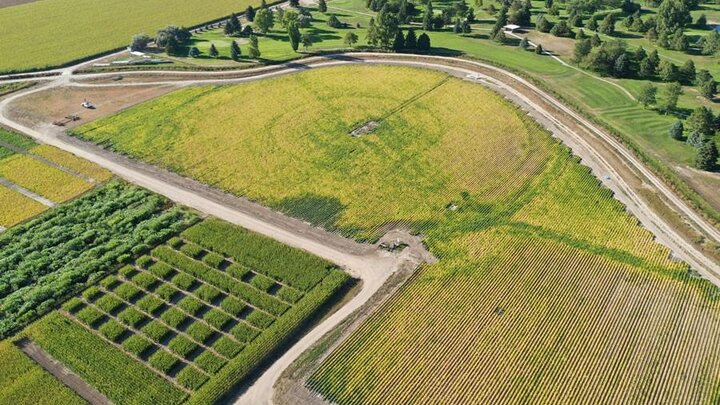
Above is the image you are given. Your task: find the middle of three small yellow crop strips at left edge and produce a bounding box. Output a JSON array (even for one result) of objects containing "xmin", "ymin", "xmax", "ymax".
[{"xmin": 0, "ymin": 155, "xmax": 92, "ymax": 203}]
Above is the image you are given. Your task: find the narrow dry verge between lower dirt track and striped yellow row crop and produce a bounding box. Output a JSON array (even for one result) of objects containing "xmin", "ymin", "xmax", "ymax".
[{"xmin": 273, "ymin": 256, "xmax": 422, "ymax": 405}]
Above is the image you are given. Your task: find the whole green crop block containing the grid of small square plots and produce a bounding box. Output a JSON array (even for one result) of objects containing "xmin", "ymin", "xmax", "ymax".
[{"xmin": 2, "ymin": 219, "xmax": 349, "ymax": 404}]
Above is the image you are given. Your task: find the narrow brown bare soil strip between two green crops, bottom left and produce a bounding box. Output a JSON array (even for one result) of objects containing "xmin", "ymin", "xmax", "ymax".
[{"xmin": 15, "ymin": 337, "xmax": 112, "ymax": 405}]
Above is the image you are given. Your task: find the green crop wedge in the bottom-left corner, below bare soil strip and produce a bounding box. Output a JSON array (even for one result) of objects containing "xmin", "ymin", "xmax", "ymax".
[{"xmin": 0, "ymin": 340, "xmax": 86, "ymax": 405}]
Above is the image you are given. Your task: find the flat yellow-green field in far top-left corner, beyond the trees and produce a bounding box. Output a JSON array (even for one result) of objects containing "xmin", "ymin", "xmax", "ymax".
[{"xmin": 0, "ymin": 0, "xmax": 259, "ymax": 73}]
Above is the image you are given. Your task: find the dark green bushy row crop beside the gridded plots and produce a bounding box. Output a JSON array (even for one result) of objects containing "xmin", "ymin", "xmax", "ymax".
[{"xmin": 0, "ymin": 182, "xmax": 195, "ymax": 337}]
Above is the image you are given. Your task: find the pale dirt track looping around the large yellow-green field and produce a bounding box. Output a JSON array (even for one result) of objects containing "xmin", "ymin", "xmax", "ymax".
[{"xmin": 0, "ymin": 53, "xmax": 720, "ymax": 404}]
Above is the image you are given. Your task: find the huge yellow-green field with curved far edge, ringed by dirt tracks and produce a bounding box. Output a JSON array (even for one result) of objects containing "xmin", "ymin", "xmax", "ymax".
[{"xmin": 78, "ymin": 64, "xmax": 720, "ymax": 404}]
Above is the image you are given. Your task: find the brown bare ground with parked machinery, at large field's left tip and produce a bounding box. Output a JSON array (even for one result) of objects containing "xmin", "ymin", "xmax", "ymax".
[{"xmin": 9, "ymin": 85, "xmax": 175, "ymax": 128}]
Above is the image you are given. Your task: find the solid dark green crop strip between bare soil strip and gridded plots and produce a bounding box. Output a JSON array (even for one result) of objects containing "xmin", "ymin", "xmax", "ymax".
[{"xmin": 23, "ymin": 312, "xmax": 186, "ymax": 404}]
